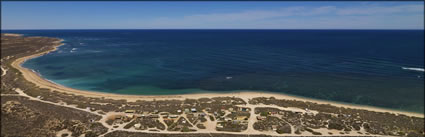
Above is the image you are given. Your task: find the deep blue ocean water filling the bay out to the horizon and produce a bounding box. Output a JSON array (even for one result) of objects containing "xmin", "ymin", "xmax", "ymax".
[{"xmin": 3, "ymin": 30, "xmax": 424, "ymax": 113}]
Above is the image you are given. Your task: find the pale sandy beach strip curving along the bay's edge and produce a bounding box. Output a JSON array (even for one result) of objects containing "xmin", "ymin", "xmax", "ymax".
[{"xmin": 11, "ymin": 35, "xmax": 424, "ymax": 118}]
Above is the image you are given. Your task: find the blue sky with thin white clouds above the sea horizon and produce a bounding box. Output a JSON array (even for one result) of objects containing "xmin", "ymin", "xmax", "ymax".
[{"xmin": 1, "ymin": 1, "xmax": 424, "ymax": 30}]
